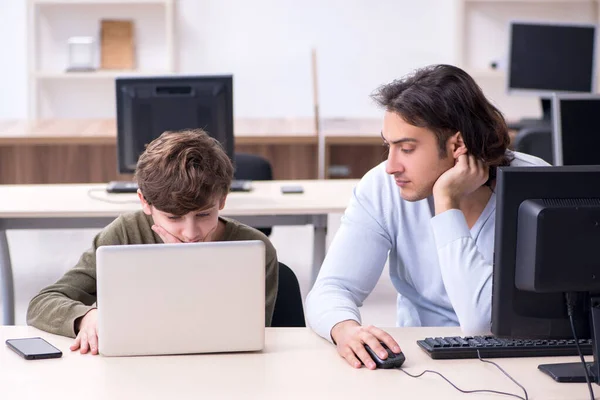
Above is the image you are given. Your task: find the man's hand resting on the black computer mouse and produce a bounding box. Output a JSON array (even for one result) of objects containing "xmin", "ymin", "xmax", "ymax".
[{"xmin": 331, "ymin": 320, "xmax": 400, "ymax": 369}]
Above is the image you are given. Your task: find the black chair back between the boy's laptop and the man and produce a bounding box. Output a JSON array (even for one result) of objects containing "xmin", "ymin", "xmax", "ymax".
[{"xmin": 271, "ymin": 262, "xmax": 306, "ymax": 328}]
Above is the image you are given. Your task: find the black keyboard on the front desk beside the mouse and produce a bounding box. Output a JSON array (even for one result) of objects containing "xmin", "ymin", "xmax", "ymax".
[{"xmin": 417, "ymin": 336, "xmax": 592, "ymax": 360}]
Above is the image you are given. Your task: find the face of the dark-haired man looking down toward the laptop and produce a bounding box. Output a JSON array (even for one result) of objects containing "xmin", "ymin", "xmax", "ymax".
[{"xmin": 381, "ymin": 111, "xmax": 454, "ymax": 201}]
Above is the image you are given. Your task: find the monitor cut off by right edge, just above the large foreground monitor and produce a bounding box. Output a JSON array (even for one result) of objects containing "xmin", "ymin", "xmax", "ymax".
[{"xmin": 552, "ymin": 94, "xmax": 600, "ymax": 165}]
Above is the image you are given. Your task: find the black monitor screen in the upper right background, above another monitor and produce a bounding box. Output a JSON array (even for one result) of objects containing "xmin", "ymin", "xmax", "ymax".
[{"xmin": 508, "ymin": 22, "xmax": 596, "ymax": 93}]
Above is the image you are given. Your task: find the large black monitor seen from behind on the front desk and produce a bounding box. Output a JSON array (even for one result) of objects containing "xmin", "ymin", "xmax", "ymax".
[{"xmin": 492, "ymin": 166, "xmax": 600, "ymax": 384}]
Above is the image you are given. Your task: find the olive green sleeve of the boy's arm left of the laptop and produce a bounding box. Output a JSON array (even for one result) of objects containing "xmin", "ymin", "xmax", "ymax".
[{"xmin": 27, "ymin": 218, "xmax": 124, "ymax": 337}]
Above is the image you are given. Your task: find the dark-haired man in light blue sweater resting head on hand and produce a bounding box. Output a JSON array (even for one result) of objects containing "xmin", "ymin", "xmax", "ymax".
[{"xmin": 306, "ymin": 65, "xmax": 546, "ymax": 369}]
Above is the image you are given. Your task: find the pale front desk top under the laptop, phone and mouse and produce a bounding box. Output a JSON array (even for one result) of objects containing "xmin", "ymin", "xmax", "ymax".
[{"xmin": 0, "ymin": 326, "xmax": 600, "ymax": 400}]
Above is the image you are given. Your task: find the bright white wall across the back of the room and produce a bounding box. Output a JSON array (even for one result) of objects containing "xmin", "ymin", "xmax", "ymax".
[{"xmin": 0, "ymin": 0, "xmax": 598, "ymax": 119}]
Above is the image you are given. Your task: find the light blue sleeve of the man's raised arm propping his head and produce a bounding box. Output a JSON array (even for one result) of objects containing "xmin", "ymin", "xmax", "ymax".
[{"xmin": 431, "ymin": 210, "xmax": 492, "ymax": 335}]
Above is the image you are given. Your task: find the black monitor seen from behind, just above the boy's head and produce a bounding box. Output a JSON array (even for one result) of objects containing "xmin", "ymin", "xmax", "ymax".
[{"xmin": 116, "ymin": 75, "xmax": 234, "ymax": 174}]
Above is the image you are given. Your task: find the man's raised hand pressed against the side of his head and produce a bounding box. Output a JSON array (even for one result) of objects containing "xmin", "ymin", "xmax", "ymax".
[{"xmin": 433, "ymin": 154, "xmax": 490, "ymax": 215}]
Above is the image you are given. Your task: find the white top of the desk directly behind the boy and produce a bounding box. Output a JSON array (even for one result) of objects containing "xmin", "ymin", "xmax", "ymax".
[{"xmin": 0, "ymin": 179, "xmax": 358, "ymax": 218}]
